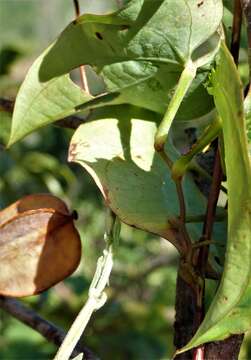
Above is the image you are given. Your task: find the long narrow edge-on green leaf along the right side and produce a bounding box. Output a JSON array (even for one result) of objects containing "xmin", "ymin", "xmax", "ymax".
[{"xmin": 177, "ymin": 44, "xmax": 251, "ymax": 351}]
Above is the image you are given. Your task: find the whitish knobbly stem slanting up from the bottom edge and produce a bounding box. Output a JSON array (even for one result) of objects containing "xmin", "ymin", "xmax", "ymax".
[{"xmin": 55, "ymin": 246, "xmax": 113, "ymax": 360}]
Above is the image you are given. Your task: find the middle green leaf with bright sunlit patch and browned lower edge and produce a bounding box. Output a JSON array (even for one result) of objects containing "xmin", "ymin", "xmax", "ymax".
[{"xmin": 69, "ymin": 106, "xmax": 209, "ymax": 248}]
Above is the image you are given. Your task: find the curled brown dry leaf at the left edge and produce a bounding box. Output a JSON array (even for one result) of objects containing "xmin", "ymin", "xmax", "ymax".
[{"xmin": 0, "ymin": 194, "xmax": 81, "ymax": 297}]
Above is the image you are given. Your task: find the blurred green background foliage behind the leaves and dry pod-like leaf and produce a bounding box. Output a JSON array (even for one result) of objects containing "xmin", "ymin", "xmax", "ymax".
[{"xmin": 0, "ymin": 0, "xmax": 177, "ymax": 360}]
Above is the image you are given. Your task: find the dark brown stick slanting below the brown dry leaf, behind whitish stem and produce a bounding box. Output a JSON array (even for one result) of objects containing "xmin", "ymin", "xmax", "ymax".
[{"xmin": 0, "ymin": 296, "xmax": 98, "ymax": 360}]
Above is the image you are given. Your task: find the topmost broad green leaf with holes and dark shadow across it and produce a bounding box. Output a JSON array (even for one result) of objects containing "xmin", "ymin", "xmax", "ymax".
[{"xmin": 8, "ymin": 0, "xmax": 222, "ymax": 146}]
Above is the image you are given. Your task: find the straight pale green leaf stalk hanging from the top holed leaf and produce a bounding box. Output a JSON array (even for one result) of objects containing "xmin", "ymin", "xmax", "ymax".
[{"xmin": 154, "ymin": 61, "xmax": 197, "ymax": 152}]
